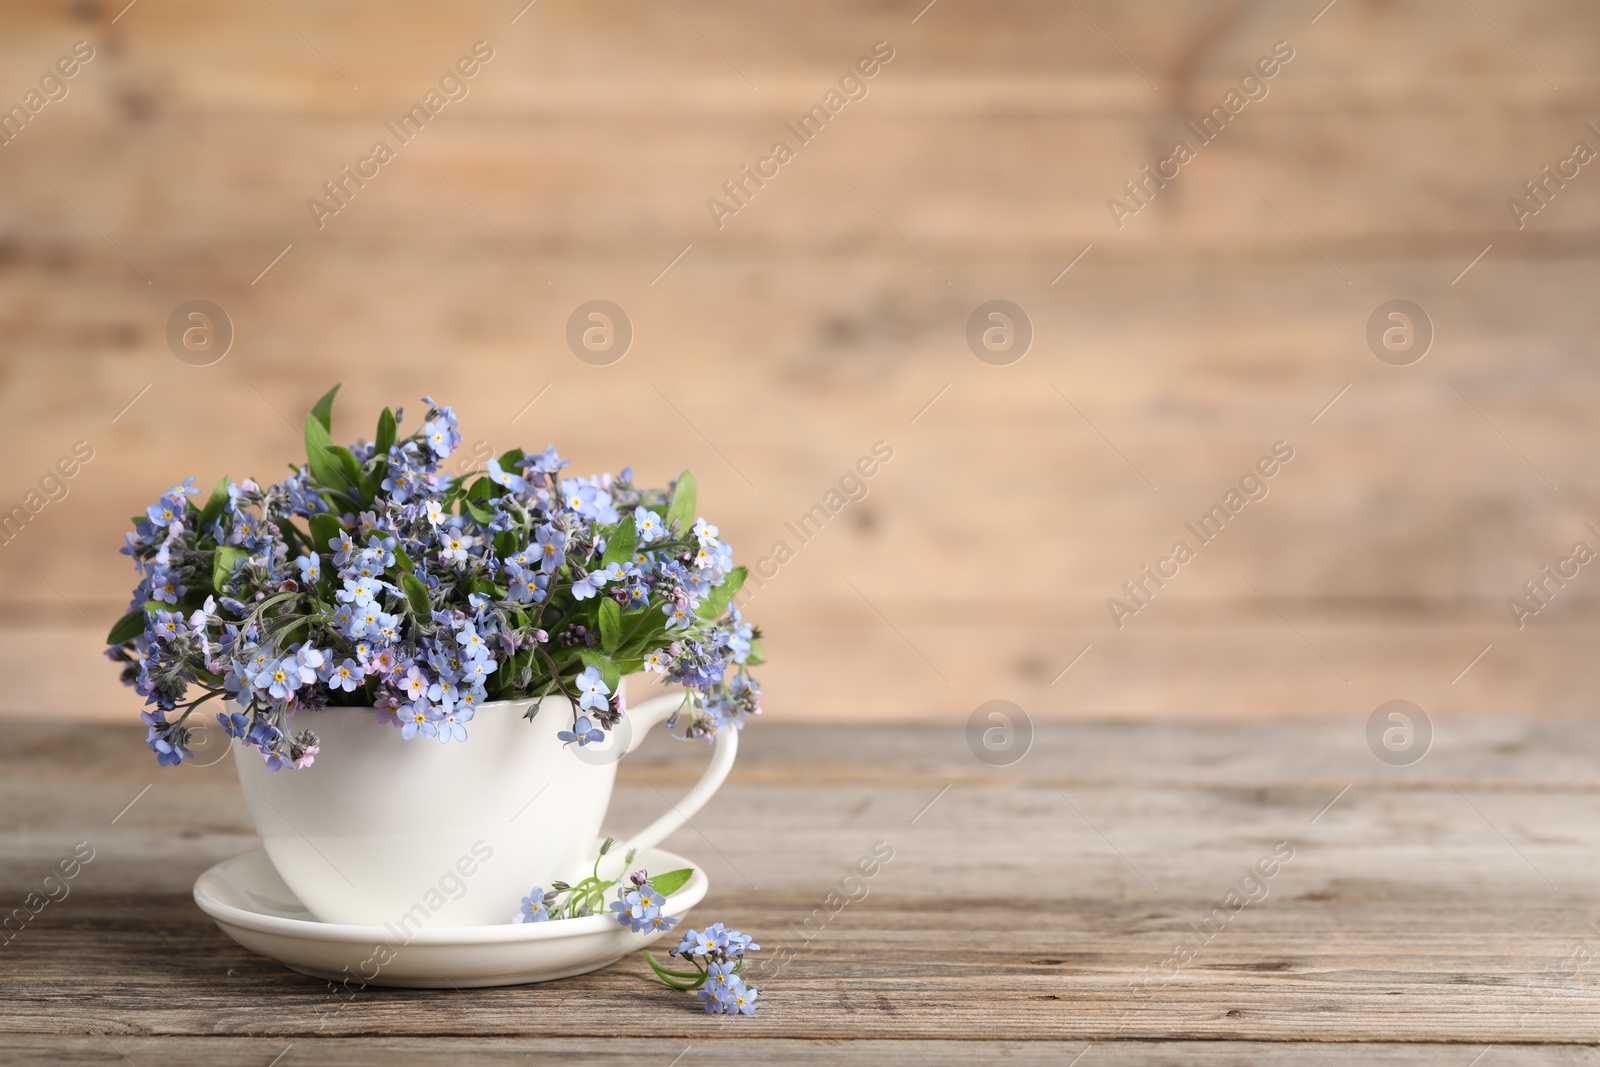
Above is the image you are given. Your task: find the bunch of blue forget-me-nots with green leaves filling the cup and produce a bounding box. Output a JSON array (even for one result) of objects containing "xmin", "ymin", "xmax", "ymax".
[{"xmin": 107, "ymin": 386, "xmax": 762, "ymax": 769}]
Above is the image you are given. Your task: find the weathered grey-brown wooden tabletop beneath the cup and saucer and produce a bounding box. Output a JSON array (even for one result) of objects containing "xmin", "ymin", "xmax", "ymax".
[{"xmin": 0, "ymin": 720, "xmax": 1600, "ymax": 1067}]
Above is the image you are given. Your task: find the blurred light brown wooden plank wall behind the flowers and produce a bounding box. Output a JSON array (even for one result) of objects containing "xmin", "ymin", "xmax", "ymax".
[{"xmin": 0, "ymin": 0, "xmax": 1600, "ymax": 721}]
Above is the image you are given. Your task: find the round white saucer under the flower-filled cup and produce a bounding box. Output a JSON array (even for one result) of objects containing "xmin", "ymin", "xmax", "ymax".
[{"xmin": 195, "ymin": 848, "xmax": 710, "ymax": 990}]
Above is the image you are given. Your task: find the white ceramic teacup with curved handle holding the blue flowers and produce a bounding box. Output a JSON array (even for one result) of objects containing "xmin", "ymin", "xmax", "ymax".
[{"xmin": 234, "ymin": 693, "xmax": 739, "ymax": 941}]
